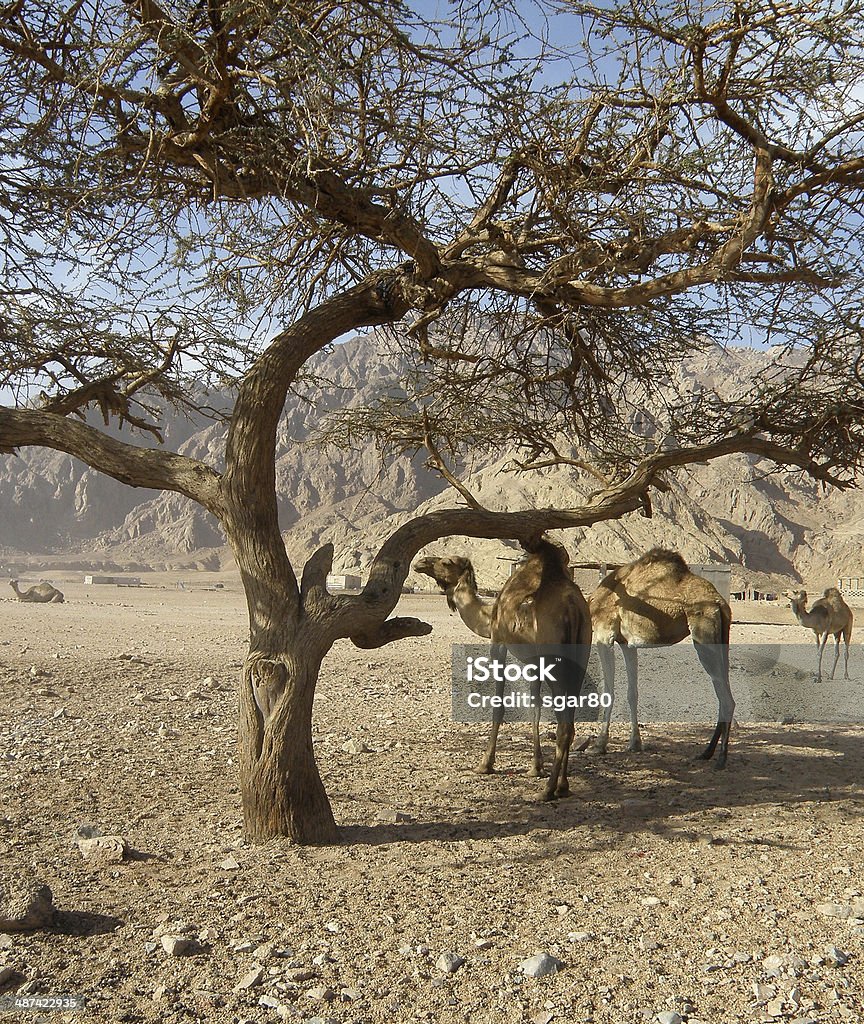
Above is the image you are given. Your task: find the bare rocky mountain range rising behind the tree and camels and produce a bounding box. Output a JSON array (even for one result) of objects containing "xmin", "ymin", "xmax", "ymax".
[{"xmin": 0, "ymin": 336, "xmax": 864, "ymax": 587}]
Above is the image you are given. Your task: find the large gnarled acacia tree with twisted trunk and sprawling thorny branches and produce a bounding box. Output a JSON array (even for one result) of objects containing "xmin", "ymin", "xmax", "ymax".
[{"xmin": 0, "ymin": 0, "xmax": 864, "ymax": 842}]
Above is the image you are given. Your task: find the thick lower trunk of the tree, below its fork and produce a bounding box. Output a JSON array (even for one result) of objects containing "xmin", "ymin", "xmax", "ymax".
[{"xmin": 239, "ymin": 638, "xmax": 338, "ymax": 844}]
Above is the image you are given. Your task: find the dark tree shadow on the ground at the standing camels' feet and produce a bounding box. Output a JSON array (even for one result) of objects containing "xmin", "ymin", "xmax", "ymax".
[{"xmin": 331, "ymin": 725, "xmax": 864, "ymax": 851}]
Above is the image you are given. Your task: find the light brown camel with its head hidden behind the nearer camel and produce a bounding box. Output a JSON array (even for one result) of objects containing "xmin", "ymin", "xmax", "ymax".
[{"xmin": 588, "ymin": 548, "xmax": 735, "ymax": 768}]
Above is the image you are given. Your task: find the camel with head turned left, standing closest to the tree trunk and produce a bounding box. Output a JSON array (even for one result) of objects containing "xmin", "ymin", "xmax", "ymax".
[{"xmin": 414, "ymin": 539, "xmax": 591, "ymax": 800}]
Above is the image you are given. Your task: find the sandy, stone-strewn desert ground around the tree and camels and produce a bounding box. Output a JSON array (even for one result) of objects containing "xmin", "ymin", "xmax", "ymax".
[{"xmin": 0, "ymin": 573, "xmax": 864, "ymax": 1024}]
